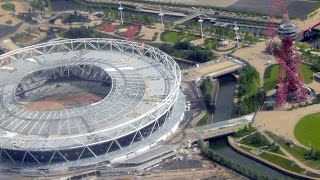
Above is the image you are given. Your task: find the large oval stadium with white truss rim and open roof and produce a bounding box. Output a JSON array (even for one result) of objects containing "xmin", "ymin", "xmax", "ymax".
[{"xmin": 0, "ymin": 38, "xmax": 185, "ymax": 172}]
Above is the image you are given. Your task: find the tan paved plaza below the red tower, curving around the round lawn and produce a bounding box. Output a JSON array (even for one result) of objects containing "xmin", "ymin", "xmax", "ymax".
[{"xmin": 255, "ymin": 104, "xmax": 320, "ymax": 145}]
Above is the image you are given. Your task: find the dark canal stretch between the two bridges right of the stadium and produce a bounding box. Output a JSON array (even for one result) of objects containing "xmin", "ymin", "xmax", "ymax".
[{"xmin": 213, "ymin": 74, "xmax": 237, "ymax": 122}]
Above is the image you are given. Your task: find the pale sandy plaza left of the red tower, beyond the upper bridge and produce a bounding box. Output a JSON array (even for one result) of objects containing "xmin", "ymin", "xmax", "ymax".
[{"xmin": 233, "ymin": 42, "xmax": 277, "ymax": 85}]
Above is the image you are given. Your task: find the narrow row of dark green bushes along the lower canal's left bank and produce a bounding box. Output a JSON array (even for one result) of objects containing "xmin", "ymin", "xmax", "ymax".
[{"xmin": 198, "ymin": 140, "xmax": 268, "ymax": 179}]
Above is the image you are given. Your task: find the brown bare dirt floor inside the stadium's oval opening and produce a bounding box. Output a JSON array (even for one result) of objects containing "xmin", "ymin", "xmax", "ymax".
[{"xmin": 24, "ymin": 93, "xmax": 102, "ymax": 111}]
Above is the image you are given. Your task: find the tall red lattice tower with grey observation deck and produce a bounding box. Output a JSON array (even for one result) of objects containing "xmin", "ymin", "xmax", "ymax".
[{"xmin": 267, "ymin": 0, "xmax": 308, "ymax": 107}]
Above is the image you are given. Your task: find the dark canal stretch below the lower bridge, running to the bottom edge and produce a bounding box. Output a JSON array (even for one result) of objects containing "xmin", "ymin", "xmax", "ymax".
[{"xmin": 209, "ymin": 137, "xmax": 295, "ymax": 180}]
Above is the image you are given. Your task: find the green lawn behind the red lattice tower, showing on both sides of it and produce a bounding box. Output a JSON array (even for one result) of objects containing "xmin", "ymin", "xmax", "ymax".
[{"xmin": 263, "ymin": 64, "xmax": 317, "ymax": 91}]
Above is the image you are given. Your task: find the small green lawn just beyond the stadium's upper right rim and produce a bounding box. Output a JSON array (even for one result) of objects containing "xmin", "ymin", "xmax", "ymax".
[{"xmin": 161, "ymin": 31, "xmax": 200, "ymax": 43}]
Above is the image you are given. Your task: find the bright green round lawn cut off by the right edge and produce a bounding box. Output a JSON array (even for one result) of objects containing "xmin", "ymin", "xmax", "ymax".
[{"xmin": 294, "ymin": 113, "xmax": 320, "ymax": 149}]
